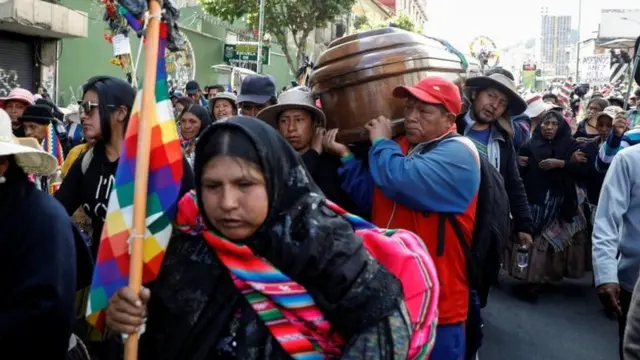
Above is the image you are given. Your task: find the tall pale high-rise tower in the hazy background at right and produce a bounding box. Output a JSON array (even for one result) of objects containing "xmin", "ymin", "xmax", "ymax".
[{"xmin": 540, "ymin": 7, "xmax": 572, "ymax": 76}]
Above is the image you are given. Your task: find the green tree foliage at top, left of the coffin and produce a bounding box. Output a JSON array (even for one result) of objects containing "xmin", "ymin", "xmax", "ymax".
[{"xmin": 200, "ymin": 0, "xmax": 356, "ymax": 73}]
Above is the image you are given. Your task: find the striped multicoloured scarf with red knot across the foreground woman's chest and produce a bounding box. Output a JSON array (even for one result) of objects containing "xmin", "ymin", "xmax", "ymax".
[{"xmin": 176, "ymin": 192, "xmax": 344, "ymax": 360}]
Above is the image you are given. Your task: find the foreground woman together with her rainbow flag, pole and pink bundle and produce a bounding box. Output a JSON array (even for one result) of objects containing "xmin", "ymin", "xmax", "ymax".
[{"xmin": 81, "ymin": 1, "xmax": 430, "ymax": 360}]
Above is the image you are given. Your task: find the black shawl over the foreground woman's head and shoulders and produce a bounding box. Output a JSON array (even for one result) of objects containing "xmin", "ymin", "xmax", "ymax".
[{"xmin": 141, "ymin": 117, "xmax": 410, "ymax": 360}]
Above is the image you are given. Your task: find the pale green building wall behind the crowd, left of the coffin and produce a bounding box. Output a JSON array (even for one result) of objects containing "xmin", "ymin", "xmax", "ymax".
[{"xmin": 55, "ymin": 0, "xmax": 294, "ymax": 106}]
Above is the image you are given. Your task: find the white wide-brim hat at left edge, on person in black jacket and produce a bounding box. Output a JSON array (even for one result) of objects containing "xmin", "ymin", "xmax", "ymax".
[{"xmin": 0, "ymin": 109, "xmax": 58, "ymax": 176}]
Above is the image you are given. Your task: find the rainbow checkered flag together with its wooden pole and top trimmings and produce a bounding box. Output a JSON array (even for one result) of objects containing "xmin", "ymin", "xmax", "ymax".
[{"xmin": 87, "ymin": 0, "xmax": 184, "ymax": 354}]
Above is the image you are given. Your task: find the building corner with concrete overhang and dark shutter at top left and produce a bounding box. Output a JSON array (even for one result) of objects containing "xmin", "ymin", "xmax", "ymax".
[{"xmin": 0, "ymin": 0, "xmax": 87, "ymax": 97}]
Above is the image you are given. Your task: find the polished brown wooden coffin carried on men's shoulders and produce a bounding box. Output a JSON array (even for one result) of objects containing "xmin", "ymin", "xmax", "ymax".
[{"xmin": 309, "ymin": 28, "xmax": 478, "ymax": 143}]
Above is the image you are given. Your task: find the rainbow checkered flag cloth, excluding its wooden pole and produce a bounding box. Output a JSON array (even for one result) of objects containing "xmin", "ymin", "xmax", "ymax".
[{"xmin": 87, "ymin": 24, "xmax": 183, "ymax": 330}]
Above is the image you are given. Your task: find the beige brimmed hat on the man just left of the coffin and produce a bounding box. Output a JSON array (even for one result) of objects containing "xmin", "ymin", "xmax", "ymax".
[{"xmin": 256, "ymin": 86, "xmax": 327, "ymax": 127}]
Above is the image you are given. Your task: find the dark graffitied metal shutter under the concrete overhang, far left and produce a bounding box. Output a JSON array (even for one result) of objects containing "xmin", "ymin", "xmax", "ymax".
[{"xmin": 0, "ymin": 32, "xmax": 36, "ymax": 97}]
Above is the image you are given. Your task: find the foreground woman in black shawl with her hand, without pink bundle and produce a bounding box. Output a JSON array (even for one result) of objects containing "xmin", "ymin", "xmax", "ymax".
[{"xmin": 106, "ymin": 116, "xmax": 411, "ymax": 360}]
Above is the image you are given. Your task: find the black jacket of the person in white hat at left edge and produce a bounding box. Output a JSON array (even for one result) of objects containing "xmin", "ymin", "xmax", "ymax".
[{"xmin": 0, "ymin": 183, "xmax": 76, "ymax": 360}]
